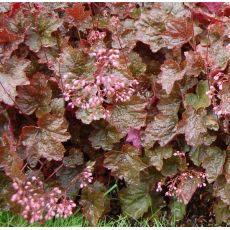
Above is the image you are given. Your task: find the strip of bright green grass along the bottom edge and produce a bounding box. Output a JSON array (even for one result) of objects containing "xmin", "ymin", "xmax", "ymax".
[{"xmin": 0, "ymin": 211, "xmax": 175, "ymax": 227}]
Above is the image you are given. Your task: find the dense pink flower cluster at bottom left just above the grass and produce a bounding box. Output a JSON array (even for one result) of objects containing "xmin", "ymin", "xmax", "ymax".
[{"xmin": 11, "ymin": 176, "xmax": 76, "ymax": 224}]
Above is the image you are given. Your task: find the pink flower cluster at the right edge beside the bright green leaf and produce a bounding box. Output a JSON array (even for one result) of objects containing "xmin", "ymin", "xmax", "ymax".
[{"xmin": 206, "ymin": 72, "xmax": 228, "ymax": 117}]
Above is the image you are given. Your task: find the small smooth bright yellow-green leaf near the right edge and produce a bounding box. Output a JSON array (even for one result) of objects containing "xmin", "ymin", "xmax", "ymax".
[{"xmin": 185, "ymin": 80, "xmax": 211, "ymax": 110}]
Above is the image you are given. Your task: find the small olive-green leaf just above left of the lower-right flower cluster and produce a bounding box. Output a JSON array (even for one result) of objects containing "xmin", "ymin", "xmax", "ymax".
[{"xmin": 145, "ymin": 145, "xmax": 173, "ymax": 171}]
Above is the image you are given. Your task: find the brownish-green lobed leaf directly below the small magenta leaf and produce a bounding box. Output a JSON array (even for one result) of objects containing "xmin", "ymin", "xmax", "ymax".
[{"xmin": 104, "ymin": 144, "xmax": 147, "ymax": 184}]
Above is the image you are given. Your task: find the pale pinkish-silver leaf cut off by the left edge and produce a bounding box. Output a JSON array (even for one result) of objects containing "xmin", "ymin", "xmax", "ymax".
[{"xmin": 0, "ymin": 56, "xmax": 30, "ymax": 105}]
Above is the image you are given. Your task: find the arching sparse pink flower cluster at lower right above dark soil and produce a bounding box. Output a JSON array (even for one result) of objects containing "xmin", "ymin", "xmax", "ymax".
[{"xmin": 156, "ymin": 170, "xmax": 206, "ymax": 201}]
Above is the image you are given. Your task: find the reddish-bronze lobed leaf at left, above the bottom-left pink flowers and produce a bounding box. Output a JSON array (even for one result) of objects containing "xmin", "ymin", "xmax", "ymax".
[{"xmin": 20, "ymin": 107, "xmax": 70, "ymax": 161}]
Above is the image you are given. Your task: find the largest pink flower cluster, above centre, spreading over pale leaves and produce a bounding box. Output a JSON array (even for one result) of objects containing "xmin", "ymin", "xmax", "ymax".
[{"xmin": 63, "ymin": 49, "xmax": 138, "ymax": 120}]
